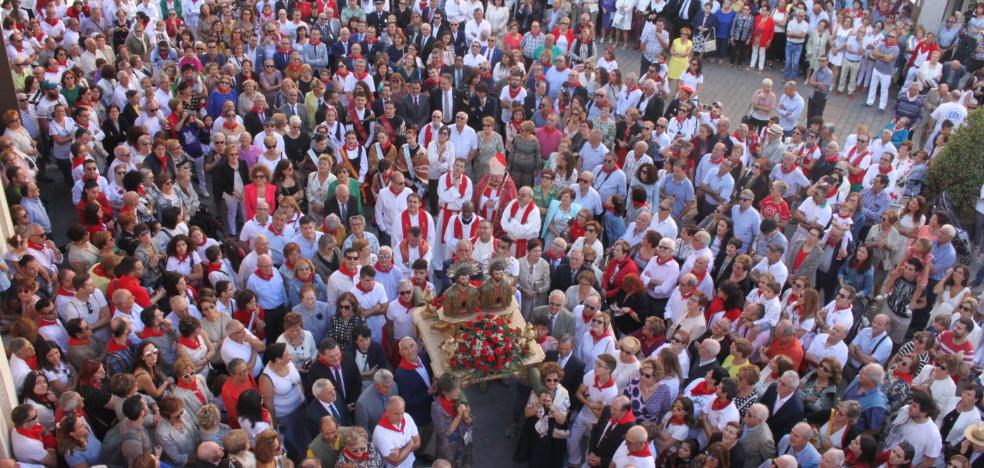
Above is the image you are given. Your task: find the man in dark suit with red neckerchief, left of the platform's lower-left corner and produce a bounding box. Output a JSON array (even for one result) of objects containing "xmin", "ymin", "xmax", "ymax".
[{"xmin": 393, "ymin": 336, "xmax": 436, "ymax": 458}]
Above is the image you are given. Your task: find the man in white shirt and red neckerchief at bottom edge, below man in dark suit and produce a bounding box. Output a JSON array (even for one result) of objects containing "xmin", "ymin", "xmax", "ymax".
[{"xmin": 372, "ymin": 396, "xmax": 420, "ymax": 468}]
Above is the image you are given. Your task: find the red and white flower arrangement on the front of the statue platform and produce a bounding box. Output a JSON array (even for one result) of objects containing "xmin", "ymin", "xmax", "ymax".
[{"xmin": 448, "ymin": 313, "xmax": 530, "ymax": 378}]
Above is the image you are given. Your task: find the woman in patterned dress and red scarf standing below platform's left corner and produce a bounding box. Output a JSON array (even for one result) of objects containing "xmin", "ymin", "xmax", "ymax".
[{"xmin": 431, "ymin": 373, "xmax": 475, "ymax": 468}]
